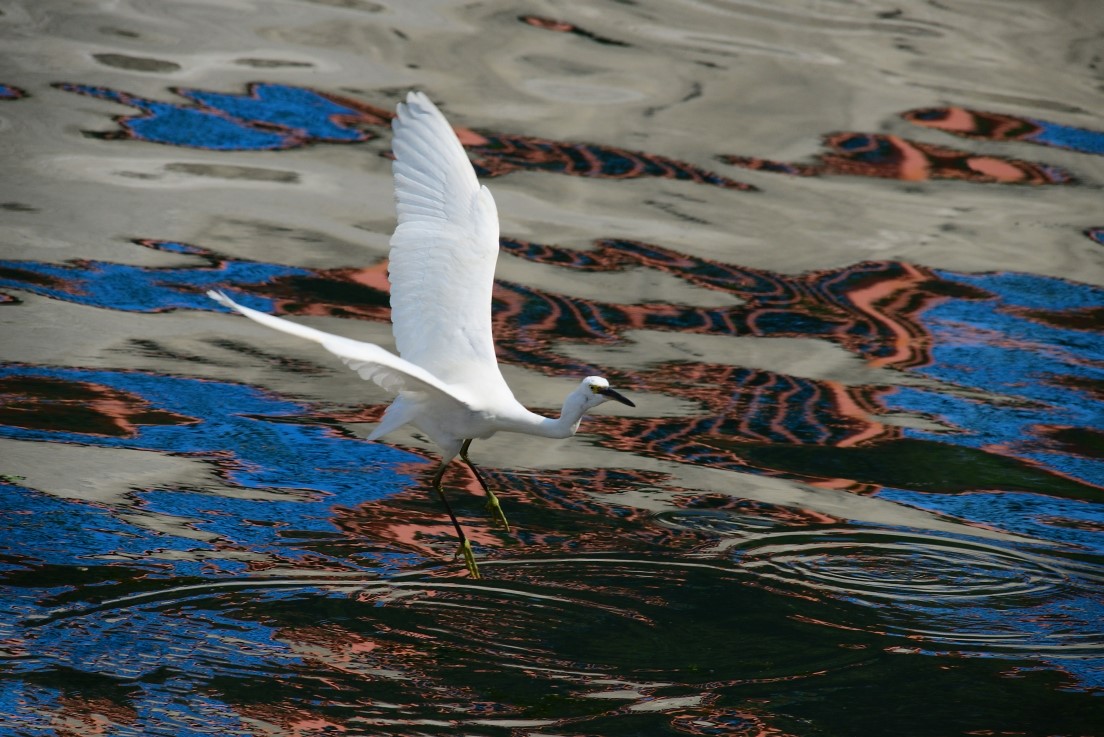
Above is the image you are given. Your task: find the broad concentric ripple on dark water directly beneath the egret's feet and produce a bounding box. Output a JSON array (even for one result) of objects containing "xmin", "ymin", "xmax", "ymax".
[{"xmin": 12, "ymin": 557, "xmax": 870, "ymax": 734}]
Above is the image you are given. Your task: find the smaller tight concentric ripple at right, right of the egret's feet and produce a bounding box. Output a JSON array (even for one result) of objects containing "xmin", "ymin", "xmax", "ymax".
[{"xmin": 737, "ymin": 522, "xmax": 1104, "ymax": 665}]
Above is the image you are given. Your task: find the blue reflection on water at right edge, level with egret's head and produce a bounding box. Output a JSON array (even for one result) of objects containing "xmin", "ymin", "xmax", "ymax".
[{"xmin": 887, "ymin": 271, "xmax": 1104, "ymax": 484}]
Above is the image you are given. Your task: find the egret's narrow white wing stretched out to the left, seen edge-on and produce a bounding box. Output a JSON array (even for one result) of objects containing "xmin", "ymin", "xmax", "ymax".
[{"xmin": 208, "ymin": 291, "xmax": 469, "ymax": 406}]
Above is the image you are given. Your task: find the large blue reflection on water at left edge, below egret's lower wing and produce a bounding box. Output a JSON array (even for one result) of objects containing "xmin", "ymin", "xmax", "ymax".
[{"xmin": 0, "ymin": 365, "xmax": 422, "ymax": 575}]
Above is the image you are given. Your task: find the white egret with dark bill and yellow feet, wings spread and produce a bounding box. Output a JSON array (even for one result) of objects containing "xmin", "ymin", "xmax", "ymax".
[{"xmin": 208, "ymin": 92, "xmax": 635, "ymax": 578}]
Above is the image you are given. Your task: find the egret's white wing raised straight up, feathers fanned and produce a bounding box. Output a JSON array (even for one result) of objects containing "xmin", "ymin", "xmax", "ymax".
[{"xmin": 389, "ymin": 92, "xmax": 513, "ymax": 399}]
